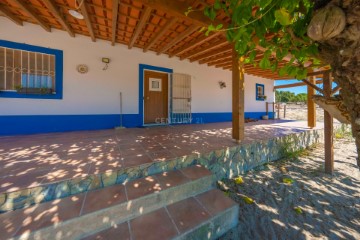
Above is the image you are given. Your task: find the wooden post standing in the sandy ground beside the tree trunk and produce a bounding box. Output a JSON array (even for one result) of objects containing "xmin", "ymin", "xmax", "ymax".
[{"xmin": 323, "ymin": 72, "xmax": 334, "ymax": 174}]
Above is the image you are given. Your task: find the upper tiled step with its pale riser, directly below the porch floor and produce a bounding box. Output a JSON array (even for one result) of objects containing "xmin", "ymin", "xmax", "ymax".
[{"xmin": 0, "ymin": 166, "xmax": 214, "ymax": 239}]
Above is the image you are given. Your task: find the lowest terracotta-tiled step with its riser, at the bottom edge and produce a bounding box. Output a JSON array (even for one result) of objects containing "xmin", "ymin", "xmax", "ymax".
[{"xmin": 83, "ymin": 189, "xmax": 239, "ymax": 240}]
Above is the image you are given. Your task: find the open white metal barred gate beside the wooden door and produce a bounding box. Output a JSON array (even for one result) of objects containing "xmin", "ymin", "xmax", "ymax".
[{"xmin": 171, "ymin": 73, "xmax": 191, "ymax": 124}]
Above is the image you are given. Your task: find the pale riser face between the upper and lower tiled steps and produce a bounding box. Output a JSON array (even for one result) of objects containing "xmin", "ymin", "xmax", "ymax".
[{"xmin": 14, "ymin": 175, "xmax": 214, "ymax": 240}]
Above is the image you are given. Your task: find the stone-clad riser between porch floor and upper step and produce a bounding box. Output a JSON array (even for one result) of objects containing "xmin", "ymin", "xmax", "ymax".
[{"xmin": 0, "ymin": 154, "xmax": 198, "ymax": 214}]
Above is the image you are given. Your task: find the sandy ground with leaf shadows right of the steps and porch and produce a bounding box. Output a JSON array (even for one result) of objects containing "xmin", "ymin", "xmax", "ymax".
[{"xmin": 219, "ymin": 130, "xmax": 360, "ymax": 240}]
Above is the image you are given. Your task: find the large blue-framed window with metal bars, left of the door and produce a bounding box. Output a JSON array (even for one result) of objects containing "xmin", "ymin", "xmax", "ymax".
[{"xmin": 0, "ymin": 41, "xmax": 62, "ymax": 99}]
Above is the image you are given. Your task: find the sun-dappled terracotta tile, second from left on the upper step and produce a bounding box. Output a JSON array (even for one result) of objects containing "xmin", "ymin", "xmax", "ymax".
[{"xmin": 16, "ymin": 194, "xmax": 85, "ymax": 235}]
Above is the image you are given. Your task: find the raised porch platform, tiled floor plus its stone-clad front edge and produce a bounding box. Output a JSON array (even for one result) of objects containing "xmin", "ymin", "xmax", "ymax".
[{"xmin": 0, "ymin": 120, "xmax": 322, "ymax": 211}]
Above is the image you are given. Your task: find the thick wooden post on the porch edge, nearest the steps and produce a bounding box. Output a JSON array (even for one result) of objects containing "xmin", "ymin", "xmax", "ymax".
[{"xmin": 232, "ymin": 46, "xmax": 245, "ymax": 142}]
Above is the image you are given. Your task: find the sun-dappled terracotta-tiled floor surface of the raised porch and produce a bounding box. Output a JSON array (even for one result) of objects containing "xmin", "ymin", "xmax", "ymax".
[{"xmin": 0, "ymin": 120, "xmax": 322, "ymax": 193}]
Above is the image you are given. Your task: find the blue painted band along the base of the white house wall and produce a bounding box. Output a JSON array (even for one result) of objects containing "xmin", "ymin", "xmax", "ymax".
[{"xmin": 0, "ymin": 112, "xmax": 273, "ymax": 136}]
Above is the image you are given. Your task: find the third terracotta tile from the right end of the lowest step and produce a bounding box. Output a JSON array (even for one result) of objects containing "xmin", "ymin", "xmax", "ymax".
[{"xmin": 130, "ymin": 208, "xmax": 177, "ymax": 240}]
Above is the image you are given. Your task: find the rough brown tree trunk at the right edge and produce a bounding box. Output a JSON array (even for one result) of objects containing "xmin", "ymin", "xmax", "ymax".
[{"xmin": 319, "ymin": 0, "xmax": 360, "ymax": 167}]
